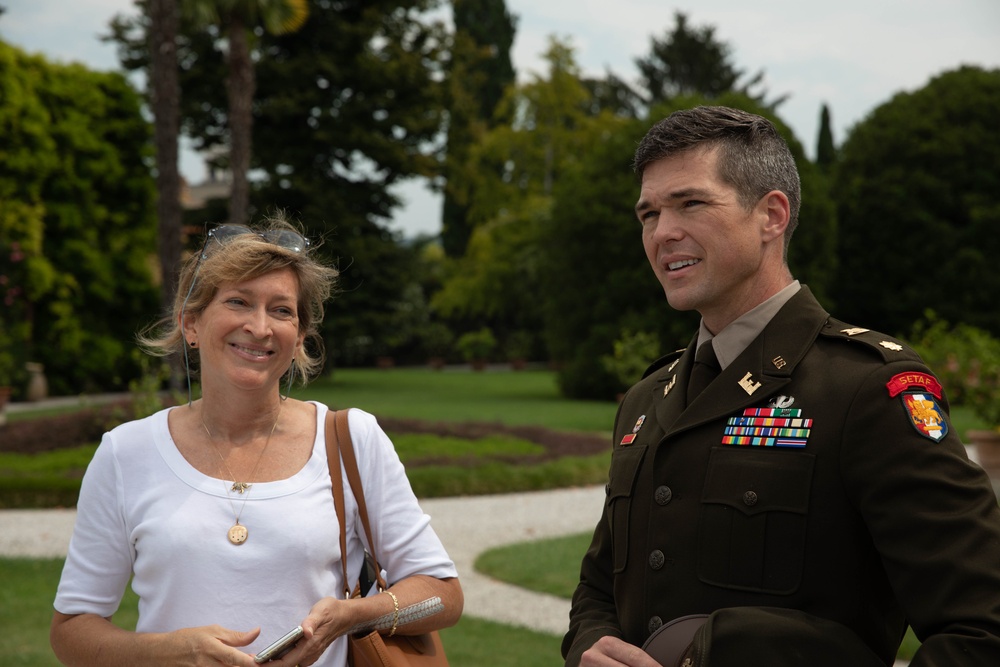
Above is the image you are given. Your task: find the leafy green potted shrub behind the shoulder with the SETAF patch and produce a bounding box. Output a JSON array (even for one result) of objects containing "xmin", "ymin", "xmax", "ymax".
[{"xmin": 913, "ymin": 311, "xmax": 1000, "ymax": 478}]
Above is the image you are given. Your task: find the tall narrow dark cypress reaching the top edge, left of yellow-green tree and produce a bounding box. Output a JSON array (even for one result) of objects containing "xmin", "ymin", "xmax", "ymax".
[{"xmin": 441, "ymin": 0, "xmax": 517, "ymax": 257}]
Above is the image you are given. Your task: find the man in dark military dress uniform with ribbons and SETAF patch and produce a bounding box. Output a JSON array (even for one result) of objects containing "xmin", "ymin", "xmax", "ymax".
[{"xmin": 563, "ymin": 107, "xmax": 1000, "ymax": 667}]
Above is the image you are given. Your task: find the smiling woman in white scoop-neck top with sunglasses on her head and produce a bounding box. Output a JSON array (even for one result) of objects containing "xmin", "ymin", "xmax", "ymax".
[{"xmin": 51, "ymin": 220, "xmax": 462, "ymax": 667}]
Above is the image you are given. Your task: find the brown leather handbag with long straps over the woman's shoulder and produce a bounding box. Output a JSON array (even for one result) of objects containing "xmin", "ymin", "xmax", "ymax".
[{"xmin": 326, "ymin": 410, "xmax": 448, "ymax": 667}]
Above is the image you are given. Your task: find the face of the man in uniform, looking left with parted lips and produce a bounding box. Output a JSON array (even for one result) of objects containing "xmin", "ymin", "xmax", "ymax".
[{"xmin": 635, "ymin": 148, "xmax": 780, "ymax": 333}]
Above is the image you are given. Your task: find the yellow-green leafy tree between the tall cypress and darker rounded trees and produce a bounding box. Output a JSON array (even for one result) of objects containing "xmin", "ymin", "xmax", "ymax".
[{"xmin": 432, "ymin": 39, "xmax": 594, "ymax": 338}]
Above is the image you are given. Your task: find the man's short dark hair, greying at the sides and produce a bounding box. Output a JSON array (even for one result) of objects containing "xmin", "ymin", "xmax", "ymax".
[{"xmin": 632, "ymin": 106, "xmax": 802, "ymax": 257}]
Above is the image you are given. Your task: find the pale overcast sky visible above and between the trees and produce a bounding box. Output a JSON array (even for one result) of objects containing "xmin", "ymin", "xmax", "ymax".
[{"xmin": 0, "ymin": 0, "xmax": 1000, "ymax": 235}]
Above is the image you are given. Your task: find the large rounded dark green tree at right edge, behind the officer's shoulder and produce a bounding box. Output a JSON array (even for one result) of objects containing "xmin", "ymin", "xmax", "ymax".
[{"xmin": 834, "ymin": 67, "xmax": 1000, "ymax": 335}]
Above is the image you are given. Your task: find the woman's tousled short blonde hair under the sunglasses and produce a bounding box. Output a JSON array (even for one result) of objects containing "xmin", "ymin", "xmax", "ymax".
[{"xmin": 137, "ymin": 214, "xmax": 338, "ymax": 383}]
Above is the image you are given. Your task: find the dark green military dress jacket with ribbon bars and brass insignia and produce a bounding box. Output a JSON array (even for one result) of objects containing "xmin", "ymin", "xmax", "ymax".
[{"xmin": 563, "ymin": 287, "xmax": 1000, "ymax": 667}]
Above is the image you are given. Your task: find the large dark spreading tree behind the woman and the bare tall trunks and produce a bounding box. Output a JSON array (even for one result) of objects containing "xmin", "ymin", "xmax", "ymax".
[{"xmin": 113, "ymin": 0, "xmax": 447, "ymax": 364}]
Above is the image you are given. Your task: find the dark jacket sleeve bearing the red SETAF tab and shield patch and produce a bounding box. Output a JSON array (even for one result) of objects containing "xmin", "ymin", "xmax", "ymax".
[{"xmin": 841, "ymin": 361, "xmax": 1000, "ymax": 667}]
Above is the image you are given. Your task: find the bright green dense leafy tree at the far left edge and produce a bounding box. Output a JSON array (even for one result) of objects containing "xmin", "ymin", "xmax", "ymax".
[{"xmin": 0, "ymin": 43, "xmax": 158, "ymax": 394}]
